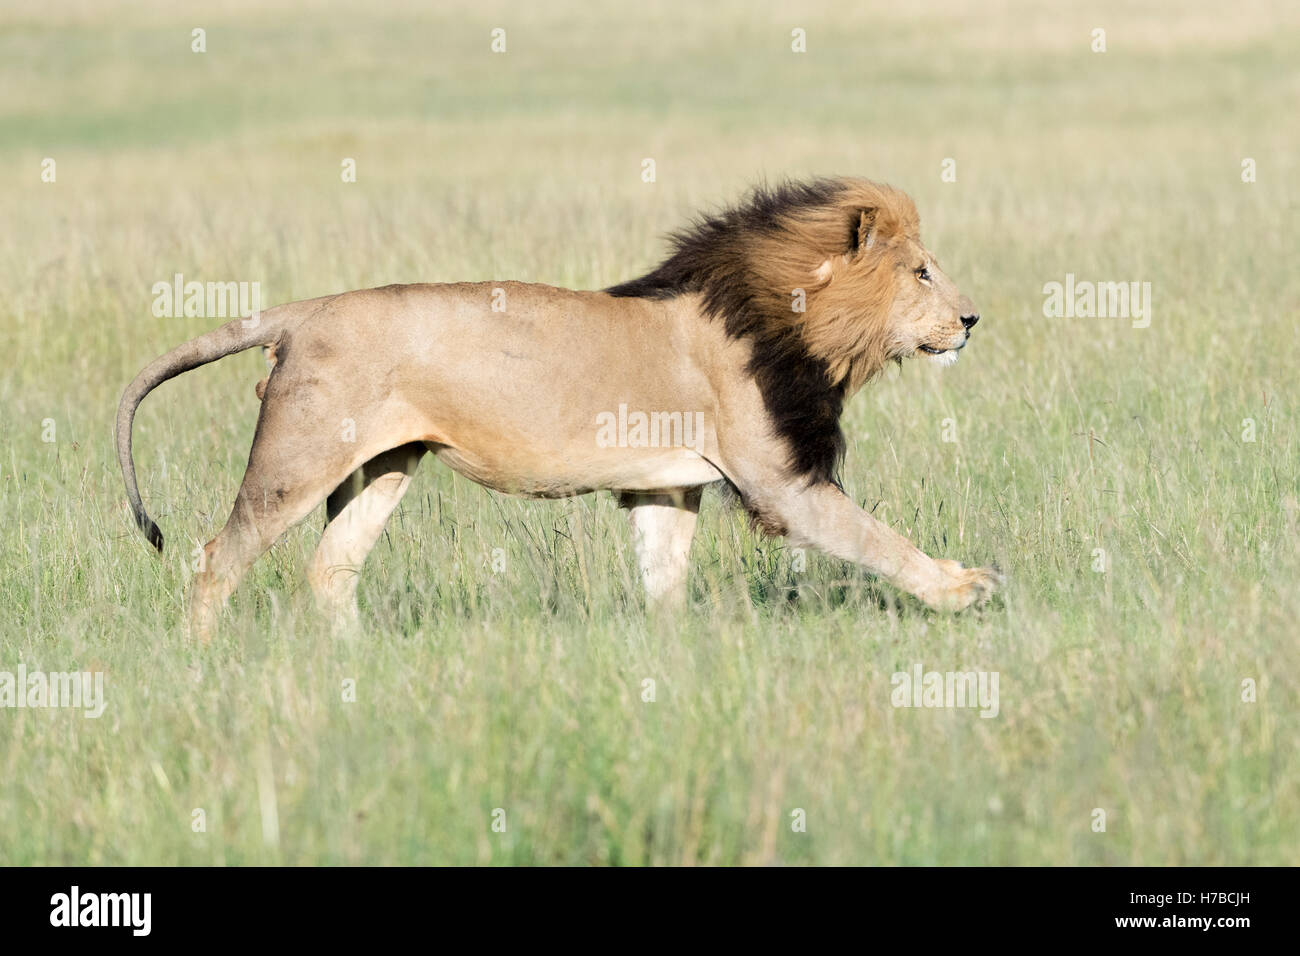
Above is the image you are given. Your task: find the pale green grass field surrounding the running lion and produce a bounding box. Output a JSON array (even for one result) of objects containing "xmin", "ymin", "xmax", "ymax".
[{"xmin": 0, "ymin": 0, "xmax": 1300, "ymax": 865}]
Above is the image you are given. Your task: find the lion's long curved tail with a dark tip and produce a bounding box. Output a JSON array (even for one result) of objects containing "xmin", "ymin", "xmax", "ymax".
[{"xmin": 117, "ymin": 300, "xmax": 320, "ymax": 553}]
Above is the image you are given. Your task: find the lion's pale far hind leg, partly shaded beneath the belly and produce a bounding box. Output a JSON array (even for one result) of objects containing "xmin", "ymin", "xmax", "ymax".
[{"xmin": 307, "ymin": 444, "xmax": 425, "ymax": 624}]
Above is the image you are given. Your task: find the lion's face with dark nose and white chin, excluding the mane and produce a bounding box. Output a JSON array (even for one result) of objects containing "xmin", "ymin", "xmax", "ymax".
[{"xmin": 887, "ymin": 239, "xmax": 979, "ymax": 365}]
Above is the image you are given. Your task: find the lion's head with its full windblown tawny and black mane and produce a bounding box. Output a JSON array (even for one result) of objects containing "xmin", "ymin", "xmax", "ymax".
[{"xmin": 606, "ymin": 178, "xmax": 979, "ymax": 477}]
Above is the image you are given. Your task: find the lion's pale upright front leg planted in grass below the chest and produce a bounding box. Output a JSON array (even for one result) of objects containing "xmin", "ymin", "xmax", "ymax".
[{"xmin": 619, "ymin": 488, "xmax": 701, "ymax": 607}]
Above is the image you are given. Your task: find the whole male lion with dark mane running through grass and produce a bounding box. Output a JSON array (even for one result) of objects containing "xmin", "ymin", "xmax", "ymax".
[{"xmin": 117, "ymin": 179, "xmax": 998, "ymax": 640}]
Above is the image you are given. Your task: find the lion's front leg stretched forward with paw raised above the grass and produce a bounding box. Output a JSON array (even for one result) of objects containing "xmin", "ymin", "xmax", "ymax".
[{"xmin": 746, "ymin": 483, "xmax": 1002, "ymax": 611}]
